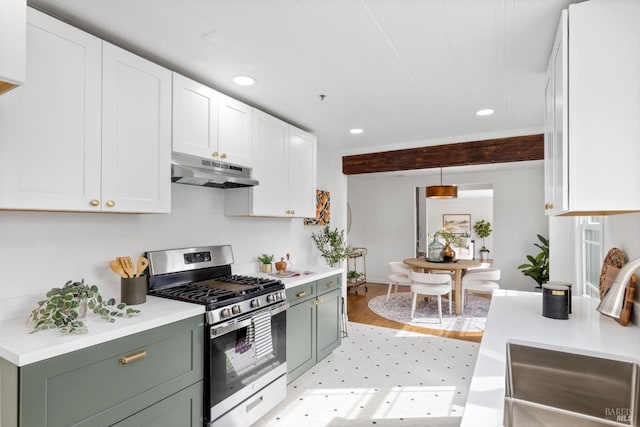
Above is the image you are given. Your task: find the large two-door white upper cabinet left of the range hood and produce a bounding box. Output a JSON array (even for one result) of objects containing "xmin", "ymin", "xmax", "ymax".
[{"xmin": 0, "ymin": 8, "xmax": 171, "ymax": 212}]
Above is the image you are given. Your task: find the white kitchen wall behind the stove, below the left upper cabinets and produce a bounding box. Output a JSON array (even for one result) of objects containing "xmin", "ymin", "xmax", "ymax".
[{"xmin": 0, "ymin": 150, "xmax": 346, "ymax": 318}]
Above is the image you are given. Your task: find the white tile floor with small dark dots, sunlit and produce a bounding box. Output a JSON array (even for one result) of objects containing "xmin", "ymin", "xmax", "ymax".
[{"xmin": 255, "ymin": 322, "xmax": 479, "ymax": 427}]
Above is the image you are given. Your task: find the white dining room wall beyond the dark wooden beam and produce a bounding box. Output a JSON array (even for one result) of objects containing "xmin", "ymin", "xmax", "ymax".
[{"xmin": 348, "ymin": 161, "xmax": 548, "ymax": 290}]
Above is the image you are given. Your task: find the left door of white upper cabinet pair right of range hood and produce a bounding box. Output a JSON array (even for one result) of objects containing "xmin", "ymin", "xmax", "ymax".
[{"xmin": 250, "ymin": 110, "xmax": 289, "ymax": 216}]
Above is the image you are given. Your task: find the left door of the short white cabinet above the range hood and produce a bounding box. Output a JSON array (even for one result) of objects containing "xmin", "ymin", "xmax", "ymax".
[{"xmin": 172, "ymin": 73, "xmax": 219, "ymax": 159}]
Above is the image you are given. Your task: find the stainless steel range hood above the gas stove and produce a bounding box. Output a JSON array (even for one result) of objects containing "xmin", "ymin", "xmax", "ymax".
[{"xmin": 171, "ymin": 152, "xmax": 258, "ymax": 188}]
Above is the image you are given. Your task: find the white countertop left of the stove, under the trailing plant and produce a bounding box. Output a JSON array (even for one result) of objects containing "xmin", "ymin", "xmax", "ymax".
[{"xmin": 0, "ymin": 295, "xmax": 205, "ymax": 366}]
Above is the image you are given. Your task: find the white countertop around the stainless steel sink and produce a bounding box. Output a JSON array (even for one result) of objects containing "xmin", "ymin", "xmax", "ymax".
[{"xmin": 461, "ymin": 289, "xmax": 640, "ymax": 427}]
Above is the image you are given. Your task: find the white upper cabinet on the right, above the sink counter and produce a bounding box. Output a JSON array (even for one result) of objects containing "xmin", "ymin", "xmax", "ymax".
[{"xmin": 545, "ymin": 0, "xmax": 640, "ymax": 215}]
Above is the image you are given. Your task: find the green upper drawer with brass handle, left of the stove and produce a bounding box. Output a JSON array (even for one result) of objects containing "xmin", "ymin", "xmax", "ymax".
[{"xmin": 19, "ymin": 316, "xmax": 204, "ymax": 427}]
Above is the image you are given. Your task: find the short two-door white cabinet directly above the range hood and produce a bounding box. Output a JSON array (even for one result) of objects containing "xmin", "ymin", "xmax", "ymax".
[{"xmin": 172, "ymin": 73, "xmax": 253, "ymax": 167}]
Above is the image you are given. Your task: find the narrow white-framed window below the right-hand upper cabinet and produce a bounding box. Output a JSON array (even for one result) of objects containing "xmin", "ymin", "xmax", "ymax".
[{"xmin": 580, "ymin": 216, "xmax": 604, "ymax": 298}]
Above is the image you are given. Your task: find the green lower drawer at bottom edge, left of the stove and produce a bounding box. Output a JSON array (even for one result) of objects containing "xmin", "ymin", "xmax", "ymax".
[{"xmin": 114, "ymin": 381, "xmax": 203, "ymax": 427}]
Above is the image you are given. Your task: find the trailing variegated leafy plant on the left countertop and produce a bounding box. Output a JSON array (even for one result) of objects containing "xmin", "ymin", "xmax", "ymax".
[{"xmin": 28, "ymin": 279, "xmax": 140, "ymax": 334}]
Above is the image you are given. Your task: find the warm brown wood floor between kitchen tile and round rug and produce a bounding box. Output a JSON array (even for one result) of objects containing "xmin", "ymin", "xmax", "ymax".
[{"xmin": 347, "ymin": 283, "xmax": 482, "ymax": 342}]
